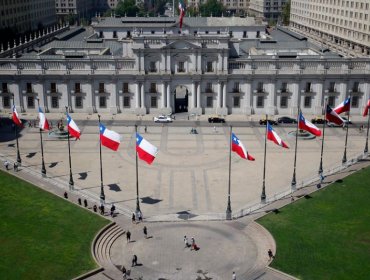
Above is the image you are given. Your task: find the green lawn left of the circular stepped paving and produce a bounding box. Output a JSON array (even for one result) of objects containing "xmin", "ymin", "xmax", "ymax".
[{"xmin": 0, "ymin": 171, "xmax": 109, "ymax": 279}]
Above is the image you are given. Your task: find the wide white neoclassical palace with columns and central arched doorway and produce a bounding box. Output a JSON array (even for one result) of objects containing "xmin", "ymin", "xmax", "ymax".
[{"xmin": 0, "ymin": 17, "xmax": 370, "ymax": 115}]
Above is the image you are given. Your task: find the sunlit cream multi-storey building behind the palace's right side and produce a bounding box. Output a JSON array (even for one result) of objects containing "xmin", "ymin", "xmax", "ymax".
[{"xmin": 290, "ymin": 0, "xmax": 370, "ymax": 57}]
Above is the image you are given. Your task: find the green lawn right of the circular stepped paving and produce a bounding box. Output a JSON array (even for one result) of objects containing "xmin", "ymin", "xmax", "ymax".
[{"xmin": 258, "ymin": 165, "xmax": 370, "ymax": 280}]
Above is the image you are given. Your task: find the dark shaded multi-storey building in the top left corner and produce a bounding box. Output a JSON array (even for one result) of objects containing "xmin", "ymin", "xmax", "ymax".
[{"xmin": 0, "ymin": 0, "xmax": 56, "ymax": 33}]
